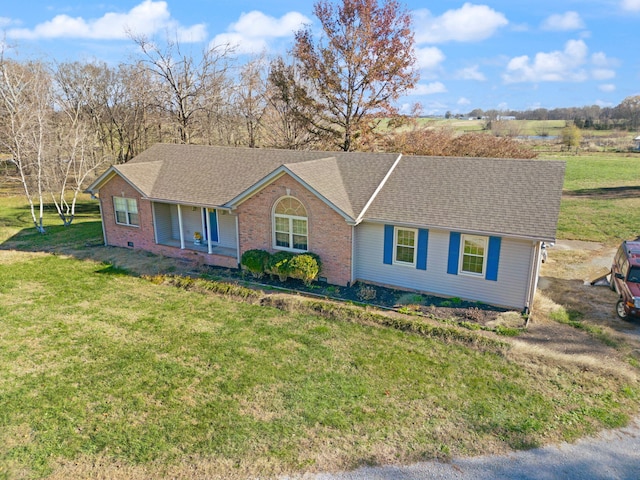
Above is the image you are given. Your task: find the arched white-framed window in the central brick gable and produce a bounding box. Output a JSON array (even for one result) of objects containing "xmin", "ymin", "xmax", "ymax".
[{"xmin": 273, "ymin": 197, "xmax": 309, "ymax": 251}]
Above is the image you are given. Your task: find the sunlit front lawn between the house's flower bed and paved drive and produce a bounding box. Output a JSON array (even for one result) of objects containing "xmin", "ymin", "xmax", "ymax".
[{"xmin": 0, "ymin": 251, "xmax": 638, "ymax": 478}]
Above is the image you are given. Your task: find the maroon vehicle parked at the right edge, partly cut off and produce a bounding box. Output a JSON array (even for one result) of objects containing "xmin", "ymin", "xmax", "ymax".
[{"xmin": 611, "ymin": 237, "xmax": 640, "ymax": 320}]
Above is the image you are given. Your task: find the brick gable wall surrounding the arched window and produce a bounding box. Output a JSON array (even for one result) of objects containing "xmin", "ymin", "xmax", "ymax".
[{"xmin": 237, "ymin": 175, "xmax": 352, "ymax": 285}]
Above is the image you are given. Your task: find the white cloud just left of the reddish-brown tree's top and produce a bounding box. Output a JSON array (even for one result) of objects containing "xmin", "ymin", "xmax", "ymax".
[{"xmin": 211, "ymin": 10, "xmax": 311, "ymax": 54}]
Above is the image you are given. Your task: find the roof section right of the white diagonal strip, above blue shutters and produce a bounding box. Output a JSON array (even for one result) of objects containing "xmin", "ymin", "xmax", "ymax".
[{"xmin": 364, "ymin": 156, "xmax": 565, "ymax": 240}]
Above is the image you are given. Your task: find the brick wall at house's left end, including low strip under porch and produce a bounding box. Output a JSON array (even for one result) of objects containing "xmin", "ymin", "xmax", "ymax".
[{"xmin": 100, "ymin": 175, "xmax": 238, "ymax": 268}]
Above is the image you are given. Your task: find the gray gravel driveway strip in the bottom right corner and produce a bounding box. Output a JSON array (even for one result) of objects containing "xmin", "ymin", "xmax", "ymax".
[{"xmin": 302, "ymin": 418, "xmax": 640, "ymax": 480}]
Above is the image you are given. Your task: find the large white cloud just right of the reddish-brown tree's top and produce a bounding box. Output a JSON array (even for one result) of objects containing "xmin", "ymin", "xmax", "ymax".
[{"xmin": 413, "ymin": 3, "xmax": 509, "ymax": 45}]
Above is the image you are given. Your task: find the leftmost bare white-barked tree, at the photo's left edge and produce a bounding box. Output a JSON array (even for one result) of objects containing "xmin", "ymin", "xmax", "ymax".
[{"xmin": 0, "ymin": 50, "xmax": 52, "ymax": 233}]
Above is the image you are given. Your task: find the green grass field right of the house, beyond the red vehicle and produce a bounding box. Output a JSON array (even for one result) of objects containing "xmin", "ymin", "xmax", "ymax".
[{"xmin": 558, "ymin": 154, "xmax": 640, "ymax": 245}]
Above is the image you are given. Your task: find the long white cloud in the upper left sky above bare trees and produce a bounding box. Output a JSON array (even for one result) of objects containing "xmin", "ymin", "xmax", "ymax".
[{"xmin": 7, "ymin": 0, "xmax": 206, "ymax": 42}]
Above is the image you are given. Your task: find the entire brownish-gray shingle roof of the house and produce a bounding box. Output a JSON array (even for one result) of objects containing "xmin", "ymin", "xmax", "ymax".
[{"xmin": 90, "ymin": 144, "xmax": 565, "ymax": 240}]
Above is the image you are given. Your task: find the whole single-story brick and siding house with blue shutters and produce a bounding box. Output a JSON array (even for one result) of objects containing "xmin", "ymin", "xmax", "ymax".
[{"xmin": 88, "ymin": 144, "xmax": 565, "ymax": 310}]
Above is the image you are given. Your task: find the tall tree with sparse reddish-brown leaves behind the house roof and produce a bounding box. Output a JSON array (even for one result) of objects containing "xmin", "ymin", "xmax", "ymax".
[{"xmin": 293, "ymin": 0, "xmax": 418, "ymax": 151}]
